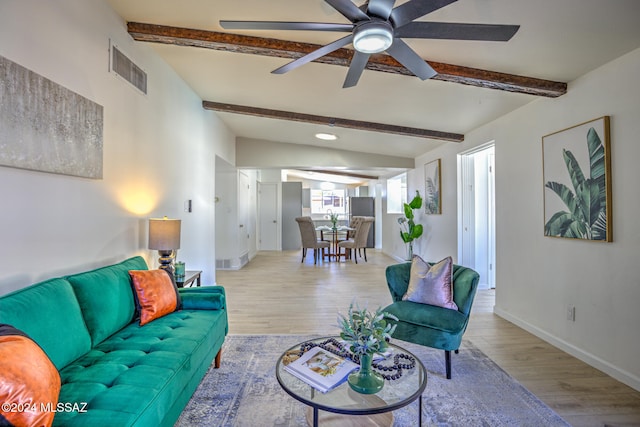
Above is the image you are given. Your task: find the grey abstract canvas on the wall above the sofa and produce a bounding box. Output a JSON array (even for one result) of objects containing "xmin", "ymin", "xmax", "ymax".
[{"xmin": 0, "ymin": 56, "xmax": 103, "ymax": 179}]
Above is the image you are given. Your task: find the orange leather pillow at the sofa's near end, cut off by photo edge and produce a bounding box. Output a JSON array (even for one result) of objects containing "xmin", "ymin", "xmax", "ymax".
[{"xmin": 0, "ymin": 324, "xmax": 60, "ymax": 427}]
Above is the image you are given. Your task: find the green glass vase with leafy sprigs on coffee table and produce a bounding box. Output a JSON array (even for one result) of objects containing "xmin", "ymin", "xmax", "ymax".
[{"xmin": 338, "ymin": 303, "xmax": 398, "ymax": 394}]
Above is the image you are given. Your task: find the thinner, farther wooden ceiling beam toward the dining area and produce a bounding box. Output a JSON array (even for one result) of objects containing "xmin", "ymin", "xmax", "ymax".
[{"xmin": 202, "ymin": 101, "xmax": 464, "ymax": 142}]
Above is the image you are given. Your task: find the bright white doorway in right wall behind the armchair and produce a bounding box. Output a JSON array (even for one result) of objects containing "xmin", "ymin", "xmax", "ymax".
[{"xmin": 458, "ymin": 142, "xmax": 496, "ymax": 289}]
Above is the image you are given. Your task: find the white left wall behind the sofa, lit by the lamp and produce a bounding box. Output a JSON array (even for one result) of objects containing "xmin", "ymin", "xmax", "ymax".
[{"xmin": 0, "ymin": 0, "xmax": 235, "ymax": 294}]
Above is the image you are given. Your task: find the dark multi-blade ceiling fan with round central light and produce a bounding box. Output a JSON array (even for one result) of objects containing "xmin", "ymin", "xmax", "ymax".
[{"xmin": 220, "ymin": 0, "xmax": 520, "ymax": 88}]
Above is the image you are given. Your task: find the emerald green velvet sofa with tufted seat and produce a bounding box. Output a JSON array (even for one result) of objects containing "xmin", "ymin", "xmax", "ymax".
[{"xmin": 0, "ymin": 257, "xmax": 228, "ymax": 427}]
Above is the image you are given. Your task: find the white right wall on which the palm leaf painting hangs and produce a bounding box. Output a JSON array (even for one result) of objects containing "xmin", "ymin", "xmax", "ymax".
[{"xmin": 409, "ymin": 49, "xmax": 640, "ymax": 389}]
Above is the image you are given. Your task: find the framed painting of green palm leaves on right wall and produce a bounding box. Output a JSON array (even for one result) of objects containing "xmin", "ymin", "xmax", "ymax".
[{"xmin": 542, "ymin": 116, "xmax": 613, "ymax": 242}]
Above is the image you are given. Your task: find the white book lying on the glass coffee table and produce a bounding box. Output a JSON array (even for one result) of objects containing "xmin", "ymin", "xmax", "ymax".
[{"xmin": 285, "ymin": 347, "xmax": 360, "ymax": 393}]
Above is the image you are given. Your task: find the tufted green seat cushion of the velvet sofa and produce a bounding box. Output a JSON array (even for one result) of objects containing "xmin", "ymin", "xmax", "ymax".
[{"xmin": 54, "ymin": 310, "xmax": 227, "ymax": 426}]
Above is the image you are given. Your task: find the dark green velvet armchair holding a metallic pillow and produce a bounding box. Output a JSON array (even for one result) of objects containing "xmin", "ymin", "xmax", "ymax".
[{"xmin": 384, "ymin": 262, "xmax": 480, "ymax": 379}]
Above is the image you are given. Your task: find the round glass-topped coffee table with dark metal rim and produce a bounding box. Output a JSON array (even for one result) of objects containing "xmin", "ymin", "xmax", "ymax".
[{"xmin": 276, "ymin": 337, "xmax": 427, "ymax": 427}]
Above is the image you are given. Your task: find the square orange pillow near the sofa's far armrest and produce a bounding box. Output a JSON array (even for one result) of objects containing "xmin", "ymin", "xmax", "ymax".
[{"xmin": 129, "ymin": 270, "xmax": 178, "ymax": 326}]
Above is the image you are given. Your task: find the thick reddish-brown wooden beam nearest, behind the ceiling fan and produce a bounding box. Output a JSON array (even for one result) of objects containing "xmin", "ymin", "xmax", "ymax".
[{"xmin": 127, "ymin": 22, "xmax": 567, "ymax": 98}]
